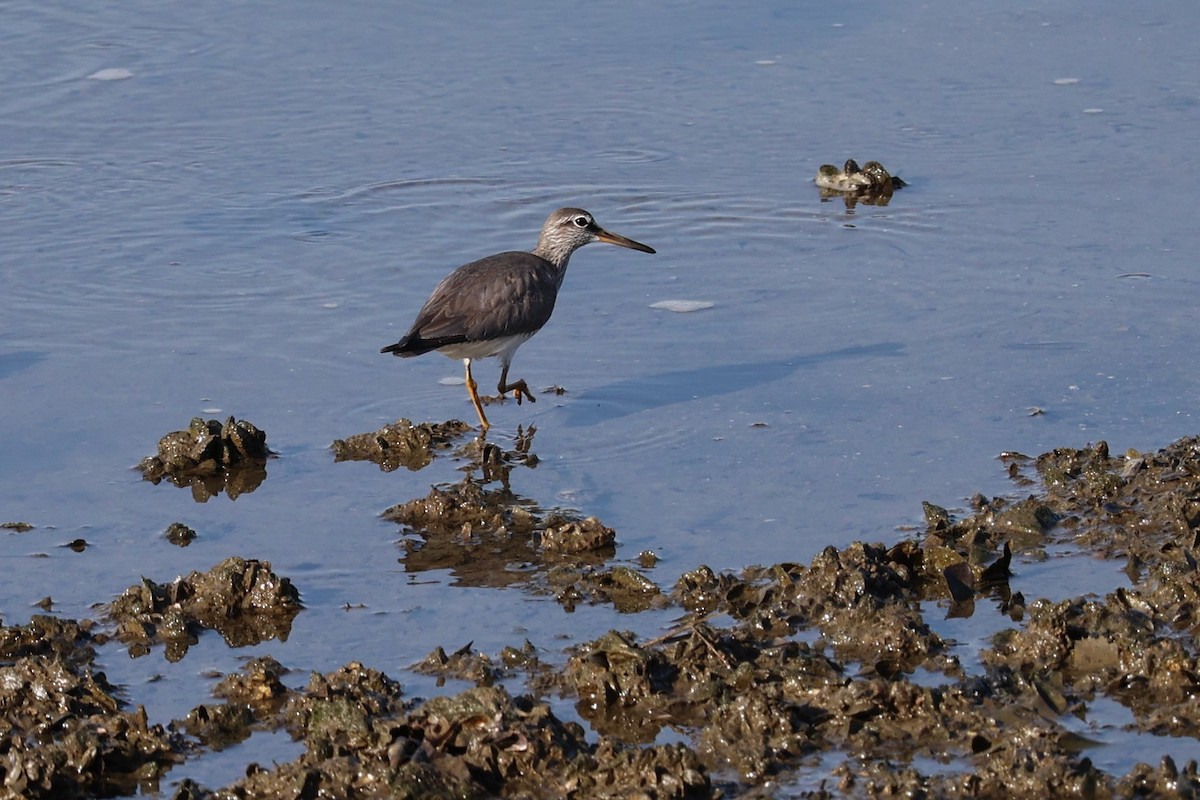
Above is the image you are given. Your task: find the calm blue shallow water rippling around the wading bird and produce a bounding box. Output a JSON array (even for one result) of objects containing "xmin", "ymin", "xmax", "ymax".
[{"xmin": 0, "ymin": 1, "xmax": 1200, "ymax": 784}]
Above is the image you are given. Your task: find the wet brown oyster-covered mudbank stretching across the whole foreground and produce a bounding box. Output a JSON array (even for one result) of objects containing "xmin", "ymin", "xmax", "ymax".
[{"xmin": 7, "ymin": 429, "xmax": 1200, "ymax": 799}]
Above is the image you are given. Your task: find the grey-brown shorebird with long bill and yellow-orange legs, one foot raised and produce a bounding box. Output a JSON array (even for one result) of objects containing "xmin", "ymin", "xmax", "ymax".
[{"xmin": 379, "ymin": 209, "xmax": 654, "ymax": 433}]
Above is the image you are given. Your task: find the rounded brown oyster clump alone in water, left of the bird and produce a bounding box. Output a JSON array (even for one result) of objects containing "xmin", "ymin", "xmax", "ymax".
[{"xmin": 138, "ymin": 416, "xmax": 274, "ymax": 503}]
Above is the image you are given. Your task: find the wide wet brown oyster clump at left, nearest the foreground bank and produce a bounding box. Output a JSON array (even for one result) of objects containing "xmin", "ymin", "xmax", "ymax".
[{"xmin": 106, "ymin": 557, "xmax": 302, "ymax": 661}]
